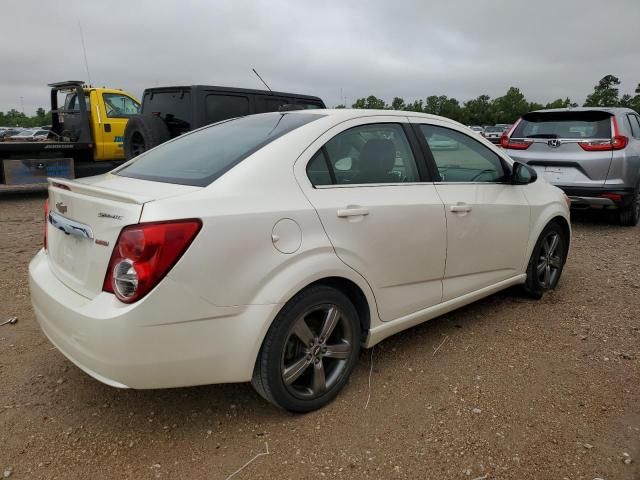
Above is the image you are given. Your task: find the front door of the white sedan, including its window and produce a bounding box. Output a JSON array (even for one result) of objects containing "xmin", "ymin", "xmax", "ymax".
[{"xmin": 411, "ymin": 118, "xmax": 530, "ymax": 301}]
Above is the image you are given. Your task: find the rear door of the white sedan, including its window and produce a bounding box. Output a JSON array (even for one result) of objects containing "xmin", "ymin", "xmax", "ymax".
[{"xmin": 296, "ymin": 116, "xmax": 446, "ymax": 321}]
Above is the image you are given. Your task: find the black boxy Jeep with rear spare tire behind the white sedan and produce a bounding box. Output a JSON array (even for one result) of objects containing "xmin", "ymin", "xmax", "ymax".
[{"xmin": 124, "ymin": 85, "xmax": 326, "ymax": 160}]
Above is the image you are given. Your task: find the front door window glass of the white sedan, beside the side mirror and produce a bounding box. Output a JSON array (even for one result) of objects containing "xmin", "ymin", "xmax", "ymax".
[{"xmin": 420, "ymin": 125, "xmax": 505, "ymax": 182}]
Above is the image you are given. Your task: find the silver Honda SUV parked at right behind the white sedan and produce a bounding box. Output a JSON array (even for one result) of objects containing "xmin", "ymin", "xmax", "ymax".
[{"xmin": 500, "ymin": 107, "xmax": 640, "ymax": 226}]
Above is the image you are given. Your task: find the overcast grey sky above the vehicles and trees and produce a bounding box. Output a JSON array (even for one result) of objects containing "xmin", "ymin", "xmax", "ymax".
[{"xmin": 0, "ymin": 0, "xmax": 640, "ymax": 114}]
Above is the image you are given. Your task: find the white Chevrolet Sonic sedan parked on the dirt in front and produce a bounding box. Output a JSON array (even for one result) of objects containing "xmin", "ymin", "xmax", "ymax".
[{"xmin": 29, "ymin": 110, "xmax": 570, "ymax": 412}]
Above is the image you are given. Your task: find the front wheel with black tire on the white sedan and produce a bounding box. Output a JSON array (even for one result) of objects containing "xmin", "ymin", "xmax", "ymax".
[{"xmin": 524, "ymin": 222, "xmax": 569, "ymax": 299}]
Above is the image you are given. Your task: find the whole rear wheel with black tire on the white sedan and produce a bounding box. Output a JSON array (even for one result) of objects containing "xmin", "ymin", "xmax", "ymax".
[{"xmin": 251, "ymin": 285, "xmax": 360, "ymax": 413}]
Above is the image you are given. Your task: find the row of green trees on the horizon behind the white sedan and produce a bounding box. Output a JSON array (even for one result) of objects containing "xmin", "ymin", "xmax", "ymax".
[{"xmin": 336, "ymin": 75, "xmax": 640, "ymax": 125}]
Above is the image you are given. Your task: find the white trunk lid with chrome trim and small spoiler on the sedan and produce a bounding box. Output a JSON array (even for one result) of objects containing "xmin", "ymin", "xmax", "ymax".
[{"xmin": 46, "ymin": 174, "xmax": 199, "ymax": 298}]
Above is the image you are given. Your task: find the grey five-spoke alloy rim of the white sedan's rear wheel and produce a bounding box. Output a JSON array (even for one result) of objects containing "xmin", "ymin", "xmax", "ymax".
[{"xmin": 281, "ymin": 304, "xmax": 354, "ymax": 399}]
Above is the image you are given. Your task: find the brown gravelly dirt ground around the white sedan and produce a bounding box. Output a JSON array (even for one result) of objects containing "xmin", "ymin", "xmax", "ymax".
[{"xmin": 0, "ymin": 196, "xmax": 640, "ymax": 480}]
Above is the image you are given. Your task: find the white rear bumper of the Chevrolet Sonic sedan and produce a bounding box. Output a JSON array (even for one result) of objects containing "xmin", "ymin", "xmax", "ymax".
[{"xmin": 29, "ymin": 251, "xmax": 279, "ymax": 389}]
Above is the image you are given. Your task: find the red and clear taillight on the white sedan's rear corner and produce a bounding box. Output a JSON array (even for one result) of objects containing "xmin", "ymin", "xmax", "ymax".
[{"xmin": 102, "ymin": 219, "xmax": 202, "ymax": 303}]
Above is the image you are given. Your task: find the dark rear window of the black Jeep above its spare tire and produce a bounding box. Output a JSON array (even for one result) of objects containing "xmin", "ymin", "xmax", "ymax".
[{"xmin": 143, "ymin": 90, "xmax": 191, "ymax": 134}]
